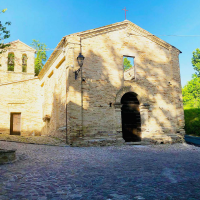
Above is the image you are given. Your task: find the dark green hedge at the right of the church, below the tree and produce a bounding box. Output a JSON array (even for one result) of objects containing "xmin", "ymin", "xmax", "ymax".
[{"xmin": 184, "ymin": 106, "xmax": 200, "ymax": 136}]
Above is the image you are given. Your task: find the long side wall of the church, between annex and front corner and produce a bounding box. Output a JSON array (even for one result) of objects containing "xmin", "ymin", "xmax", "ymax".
[{"xmin": 40, "ymin": 51, "xmax": 67, "ymax": 139}]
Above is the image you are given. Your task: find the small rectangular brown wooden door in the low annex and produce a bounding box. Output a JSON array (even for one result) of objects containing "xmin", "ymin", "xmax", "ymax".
[{"xmin": 10, "ymin": 113, "xmax": 21, "ymax": 135}]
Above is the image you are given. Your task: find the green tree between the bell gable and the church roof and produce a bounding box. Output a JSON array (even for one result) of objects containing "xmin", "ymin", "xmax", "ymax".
[{"xmin": 31, "ymin": 40, "xmax": 47, "ymax": 76}]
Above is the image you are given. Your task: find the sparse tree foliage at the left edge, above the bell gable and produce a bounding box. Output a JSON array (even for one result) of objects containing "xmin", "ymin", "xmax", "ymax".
[{"xmin": 0, "ymin": 8, "xmax": 11, "ymax": 54}]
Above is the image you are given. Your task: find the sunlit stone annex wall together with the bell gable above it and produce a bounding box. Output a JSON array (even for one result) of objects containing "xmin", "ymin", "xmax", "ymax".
[{"xmin": 0, "ymin": 40, "xmax": 43, "ymax": 136}]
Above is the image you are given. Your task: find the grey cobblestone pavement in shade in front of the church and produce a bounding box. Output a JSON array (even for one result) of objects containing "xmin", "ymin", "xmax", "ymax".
[{"xmin": 0, "ymin": 141, "xmax": 200, "ymax": 200}]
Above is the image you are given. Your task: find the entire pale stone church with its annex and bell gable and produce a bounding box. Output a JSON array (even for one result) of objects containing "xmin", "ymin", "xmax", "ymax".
[{"xmin": 0, "ymin": 20, "xmax": 185, "ymax": 146}]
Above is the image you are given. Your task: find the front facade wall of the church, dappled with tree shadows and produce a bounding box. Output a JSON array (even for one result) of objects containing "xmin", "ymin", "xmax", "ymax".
[{"xmin": 67, "ymin": 21, "xmax": 184, "ymax": 143}]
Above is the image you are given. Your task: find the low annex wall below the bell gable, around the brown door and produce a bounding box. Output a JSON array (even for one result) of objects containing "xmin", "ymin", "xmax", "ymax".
[{"xmin": 0, "ymin": 78, "xmax": 43, "ymax": 136}]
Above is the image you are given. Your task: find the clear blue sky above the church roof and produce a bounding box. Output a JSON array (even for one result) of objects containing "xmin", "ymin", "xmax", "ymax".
[{"xmin": 0, "ymin": 0, "xmax": 200, "ymax": 86}]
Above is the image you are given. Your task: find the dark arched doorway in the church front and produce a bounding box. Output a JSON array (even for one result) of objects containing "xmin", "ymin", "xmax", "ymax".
[{"xmin": 121, "ymin": 92, "xmax": 141, "ymax": 142}]
